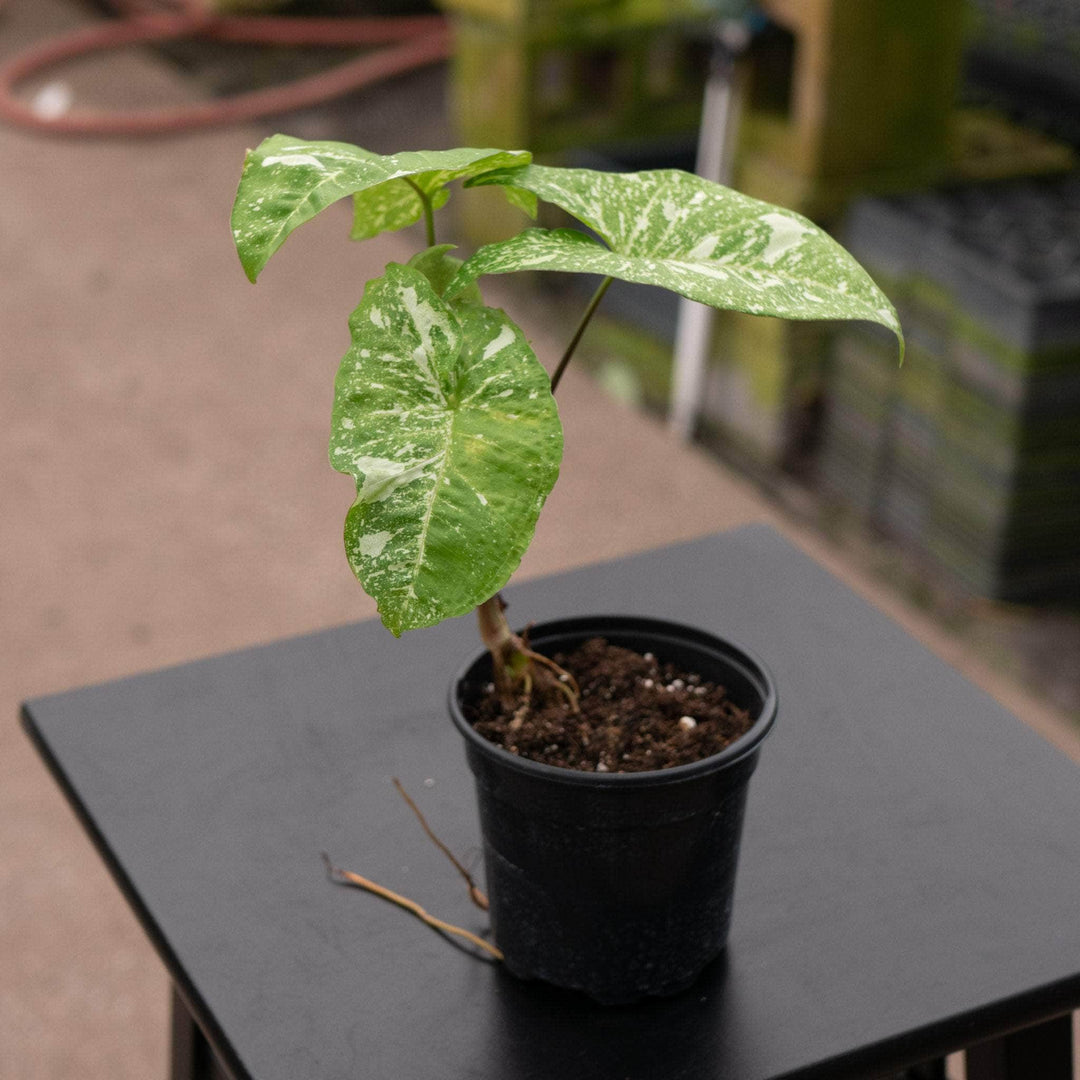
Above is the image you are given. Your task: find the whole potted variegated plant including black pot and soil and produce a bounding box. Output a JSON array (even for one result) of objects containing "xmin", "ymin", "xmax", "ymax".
[{"xmin": 232, "ymin": 135, "xmax": 903, "ymax": 1002}]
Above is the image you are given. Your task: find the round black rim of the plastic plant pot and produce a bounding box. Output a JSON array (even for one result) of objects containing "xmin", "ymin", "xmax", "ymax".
[{"xmin": 447, "ymin": 615, "xmax": 779, "ymax": 789}]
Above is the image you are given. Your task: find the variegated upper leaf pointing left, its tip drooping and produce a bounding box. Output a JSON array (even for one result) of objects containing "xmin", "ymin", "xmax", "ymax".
[{"xmin": 232, "ymin": 135, "xmax": 531, "ymax": 281}]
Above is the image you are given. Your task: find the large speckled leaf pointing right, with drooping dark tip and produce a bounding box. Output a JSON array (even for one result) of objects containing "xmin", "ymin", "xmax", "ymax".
[{"xmin": 447, "ymin": 165, "xmax": 903, "ymax": 349}]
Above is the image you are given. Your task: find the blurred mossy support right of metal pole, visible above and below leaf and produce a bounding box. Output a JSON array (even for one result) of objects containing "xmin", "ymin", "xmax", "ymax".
[{"xmin": 702, "ymin": 0, "xmax": 1075, "ymax": 476}]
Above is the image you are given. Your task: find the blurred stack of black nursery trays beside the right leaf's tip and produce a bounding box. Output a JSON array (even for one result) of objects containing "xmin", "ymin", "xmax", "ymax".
[{"xmin": 820, "ymin": 173, "xmax": 1080, "ymax": 599}]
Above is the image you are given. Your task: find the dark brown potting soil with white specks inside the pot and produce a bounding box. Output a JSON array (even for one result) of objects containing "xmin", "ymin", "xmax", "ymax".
[{"xmin": 464, "ymin": 637, "xmax": 753, "ymax": 772}]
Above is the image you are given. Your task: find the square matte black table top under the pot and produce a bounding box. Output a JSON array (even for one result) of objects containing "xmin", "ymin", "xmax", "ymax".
[{"xmin": 25, "ymin": 527, "xmax": 1080, "ymax": 1080}]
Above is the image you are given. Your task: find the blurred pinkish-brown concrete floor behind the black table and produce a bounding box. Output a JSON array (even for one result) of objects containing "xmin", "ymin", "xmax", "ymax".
[{"xmin": 0, "ymin": 0, "xmax": 1080, "ymax": 1080}]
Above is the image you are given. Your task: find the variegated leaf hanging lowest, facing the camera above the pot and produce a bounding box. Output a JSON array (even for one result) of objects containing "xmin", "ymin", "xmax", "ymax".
[{"xmin": 329, "ymin": 264, "xmax": 563, "ymax": 635}]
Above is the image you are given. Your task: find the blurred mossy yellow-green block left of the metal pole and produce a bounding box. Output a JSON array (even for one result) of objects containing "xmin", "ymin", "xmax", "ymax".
[{"xmin": 440, "ymin": 0, "xmax": 711, "ymax": 238}]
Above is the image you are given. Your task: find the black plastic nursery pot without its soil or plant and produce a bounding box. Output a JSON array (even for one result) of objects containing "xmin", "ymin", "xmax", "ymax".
[{"xmin": 449, "ymin": 616, "xmax": 777, "ymax": 1004}]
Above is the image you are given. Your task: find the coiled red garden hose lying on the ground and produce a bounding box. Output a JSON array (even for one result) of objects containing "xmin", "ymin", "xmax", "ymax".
[{"xmin": 0, "ymin": 0, "xmax": 450, "ymax": 136}]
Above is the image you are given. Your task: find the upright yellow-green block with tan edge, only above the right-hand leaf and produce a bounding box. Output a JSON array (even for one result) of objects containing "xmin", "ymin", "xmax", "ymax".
[{"xmin": 735, "ymin": 0, "xmax": 966, "ymax": 221}]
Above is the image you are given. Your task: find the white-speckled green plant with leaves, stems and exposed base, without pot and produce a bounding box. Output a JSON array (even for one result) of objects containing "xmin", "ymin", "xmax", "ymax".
[{"xmin": 232, "ymin": 135, "xmax": 903, "ymax": 705}]
